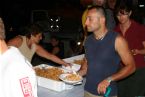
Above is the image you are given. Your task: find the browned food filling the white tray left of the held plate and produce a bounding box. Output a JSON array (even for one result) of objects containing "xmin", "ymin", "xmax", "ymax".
[{"xmin": 35, "ymin": 67, "xmax": 64, "ymax": 81}]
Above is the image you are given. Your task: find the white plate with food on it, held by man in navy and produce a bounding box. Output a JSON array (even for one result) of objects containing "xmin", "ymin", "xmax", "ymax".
[{"xmin": 59, "ymin": 73, "xmax": 83, "ymax": 84}]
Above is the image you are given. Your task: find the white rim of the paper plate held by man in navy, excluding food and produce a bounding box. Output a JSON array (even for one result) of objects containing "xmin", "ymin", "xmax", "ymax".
[{"xmin": 59, "ymin": 73, "xmax": 83, "ymax": 84}]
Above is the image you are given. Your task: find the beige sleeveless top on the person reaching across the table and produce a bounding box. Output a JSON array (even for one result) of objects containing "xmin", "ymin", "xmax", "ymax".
[{"xmin": 19, "ymin": 36, "xmax": 36, "ymax": 62}]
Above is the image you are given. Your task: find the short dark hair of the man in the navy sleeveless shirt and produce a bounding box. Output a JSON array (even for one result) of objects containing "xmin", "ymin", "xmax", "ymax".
[{"xmin": 88, "ymin": 5, "xmax": 106, "ymax": 18}]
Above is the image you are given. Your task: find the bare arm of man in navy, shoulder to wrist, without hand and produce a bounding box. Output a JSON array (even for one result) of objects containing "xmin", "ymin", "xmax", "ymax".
[{"xmin": 111, "ymin": 35, "xmax": 136, "ymax": 81}]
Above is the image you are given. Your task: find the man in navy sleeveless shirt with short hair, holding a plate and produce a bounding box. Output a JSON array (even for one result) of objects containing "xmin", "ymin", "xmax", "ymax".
[{"xmin": 79, "ymin": 6, "xmax": 136, "ymax": 97}]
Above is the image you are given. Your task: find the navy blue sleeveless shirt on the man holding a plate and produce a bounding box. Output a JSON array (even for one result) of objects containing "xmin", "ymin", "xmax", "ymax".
[{"xmin": 85, "ymin": 31, "xmax": 120, "ymax": 96}]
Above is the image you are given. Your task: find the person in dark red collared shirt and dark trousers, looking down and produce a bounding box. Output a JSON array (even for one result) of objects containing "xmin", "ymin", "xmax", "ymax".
[{"xmin": 114, "ymin": 0, "xmax": 145, "ymax": 97}]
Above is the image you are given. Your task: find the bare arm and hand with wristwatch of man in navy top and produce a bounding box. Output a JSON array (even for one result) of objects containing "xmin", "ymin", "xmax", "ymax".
[{"xmin": 97, "ymin": 36, "xmax": 136, "ymax": 93}]
